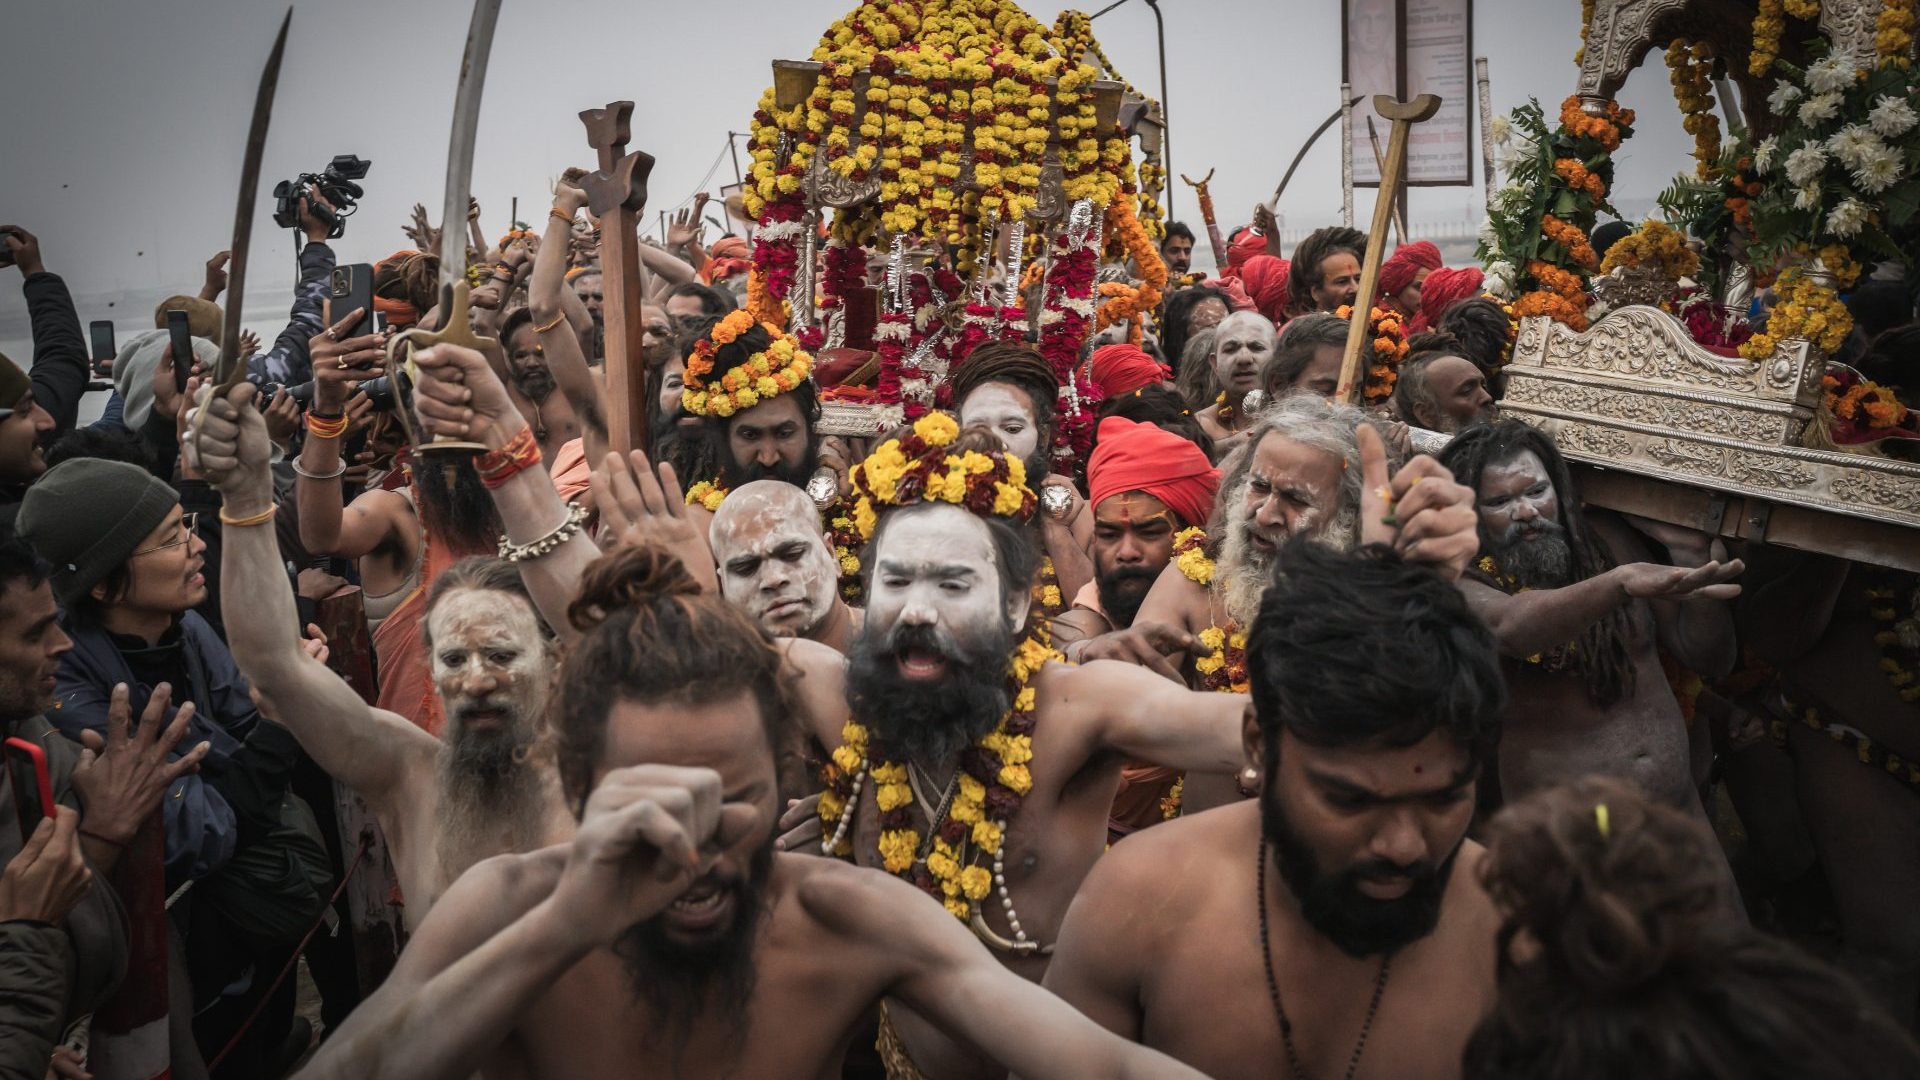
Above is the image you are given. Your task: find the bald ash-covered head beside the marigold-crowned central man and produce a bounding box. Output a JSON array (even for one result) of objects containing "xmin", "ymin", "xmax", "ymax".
[{"xmin": 707, "ymin": 480, "xmax": 839, "ymax": 638}]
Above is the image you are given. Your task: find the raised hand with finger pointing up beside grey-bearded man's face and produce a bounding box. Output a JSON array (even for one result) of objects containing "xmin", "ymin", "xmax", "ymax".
[{"xmin": 1356, "ymin": 425, "xmax": 1480, "ymax": 580}]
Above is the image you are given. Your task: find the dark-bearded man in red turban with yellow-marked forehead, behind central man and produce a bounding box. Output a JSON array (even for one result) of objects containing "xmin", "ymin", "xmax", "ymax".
[{"xmin": 1054, "ymin": 417, "xmax": 1213, "ymax": 838}]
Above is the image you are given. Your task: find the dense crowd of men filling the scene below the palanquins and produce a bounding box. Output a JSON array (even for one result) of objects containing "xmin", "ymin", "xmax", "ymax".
[{"xmin": 0, "ymin": 136, "xmax": 1920, "ymax": 1080}]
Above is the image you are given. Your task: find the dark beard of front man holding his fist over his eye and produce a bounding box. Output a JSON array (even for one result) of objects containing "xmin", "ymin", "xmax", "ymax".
[{"xmin": 612, "ymin": 834, "xmax": 774, "ymax": 1053}]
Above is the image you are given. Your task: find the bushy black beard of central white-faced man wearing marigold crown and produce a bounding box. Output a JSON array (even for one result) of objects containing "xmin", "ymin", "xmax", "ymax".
[{"xmin": 847, "ymin": 623, "xmax": 1014, "ymax": 767}]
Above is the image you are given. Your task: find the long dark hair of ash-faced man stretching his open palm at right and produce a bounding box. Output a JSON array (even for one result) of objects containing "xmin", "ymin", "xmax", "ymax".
[{"xmin": 1440, "ymin": 419, "xmax": 1634, "ymax": 709}]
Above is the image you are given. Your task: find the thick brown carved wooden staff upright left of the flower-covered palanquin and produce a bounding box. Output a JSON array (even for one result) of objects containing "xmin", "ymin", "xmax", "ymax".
[{"xmin": 580, "ymin": 102, "xmax": 653, "ymax": 454}]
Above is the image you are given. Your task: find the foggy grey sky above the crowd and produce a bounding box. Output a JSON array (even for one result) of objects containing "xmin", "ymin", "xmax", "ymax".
[{"xmin": 0, "ymin": 0, "xmax": 1690, "ymax": 336}]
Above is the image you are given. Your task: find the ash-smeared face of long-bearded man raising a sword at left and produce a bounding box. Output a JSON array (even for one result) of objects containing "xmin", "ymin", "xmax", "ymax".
[{"xmin": 426, "ymin": 588, "xmax": 553, "ymax": 746}]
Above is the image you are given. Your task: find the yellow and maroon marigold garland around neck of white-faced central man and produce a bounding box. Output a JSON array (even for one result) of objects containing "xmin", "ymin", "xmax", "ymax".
[{"xmin": 820, "ymin": 632, "xmax": 1066, "ymax": 922}]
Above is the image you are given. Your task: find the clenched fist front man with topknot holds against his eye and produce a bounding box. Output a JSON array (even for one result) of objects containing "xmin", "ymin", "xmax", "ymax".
[{"xmin": 547, "ymin": 765, "xmax": 764, "ymax": 945}]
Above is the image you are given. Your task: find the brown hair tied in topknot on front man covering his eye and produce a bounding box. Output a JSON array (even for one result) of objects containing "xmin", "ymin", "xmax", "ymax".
[{"xmin": 553, "ymin": 544, "xmax": 787, "ymax": 817}]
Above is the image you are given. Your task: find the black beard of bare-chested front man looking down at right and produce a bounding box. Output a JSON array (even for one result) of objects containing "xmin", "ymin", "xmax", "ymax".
[{"xmin": 1260, "ymin": 769, "xmax": 1465, "ymax": 957}]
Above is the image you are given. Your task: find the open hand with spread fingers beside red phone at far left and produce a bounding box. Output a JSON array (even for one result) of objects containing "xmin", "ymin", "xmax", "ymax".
[{"xmin": 73, "ymin": 682, "xmax": 209, "ymax": 846}]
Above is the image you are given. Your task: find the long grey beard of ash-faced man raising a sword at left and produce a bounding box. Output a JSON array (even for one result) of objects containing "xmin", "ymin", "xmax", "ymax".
[{"xmin": 434, "ymin": 734, "xmax": 551, "ymax": 882}]
